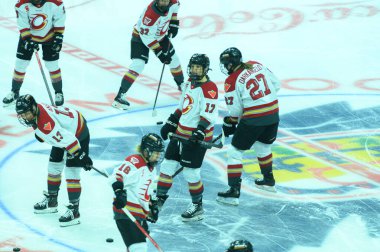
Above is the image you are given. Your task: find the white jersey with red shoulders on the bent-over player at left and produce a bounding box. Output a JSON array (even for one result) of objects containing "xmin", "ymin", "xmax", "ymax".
[{"xmin": 34, "ymin": 104, "xmax": 86, "ymax": 154}]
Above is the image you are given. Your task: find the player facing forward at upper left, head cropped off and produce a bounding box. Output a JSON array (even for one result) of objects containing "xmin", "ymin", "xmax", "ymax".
[{"xmin": 3, "ymin": 0, "xmax": 66, "ymax": 107}]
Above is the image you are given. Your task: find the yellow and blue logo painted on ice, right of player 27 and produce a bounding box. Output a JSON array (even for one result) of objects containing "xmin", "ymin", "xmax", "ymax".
[{"xmin": 230, "ymin": 102, "xmax": 380, "ymax": 200}]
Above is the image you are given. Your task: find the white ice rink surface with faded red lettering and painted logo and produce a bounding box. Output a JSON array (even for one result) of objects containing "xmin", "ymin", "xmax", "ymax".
[{"xmin": 0, "ymin": 0, "xmax": 380, "ymax": 252}]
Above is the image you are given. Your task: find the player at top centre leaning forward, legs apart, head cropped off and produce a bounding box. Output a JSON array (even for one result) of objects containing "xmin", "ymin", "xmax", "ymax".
[{"xmin": 112, "ymin": 0, "xmax": 184, "ymax": 110}]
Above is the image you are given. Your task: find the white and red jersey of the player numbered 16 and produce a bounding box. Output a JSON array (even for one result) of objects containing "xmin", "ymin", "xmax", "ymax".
[{"xmin": 111, "ymin": 154, "xmax": 157, "ymax": 219}]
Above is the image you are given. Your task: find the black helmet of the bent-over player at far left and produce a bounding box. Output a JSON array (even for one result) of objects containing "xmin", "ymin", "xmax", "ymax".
[{"xmin": 16, "ymin": 94, "xmax": 37, "ymax": 127}]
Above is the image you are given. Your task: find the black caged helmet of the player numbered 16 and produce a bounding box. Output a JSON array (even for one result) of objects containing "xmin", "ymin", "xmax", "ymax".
[{"xmin": 140, "ymin": 133, "xmax": 165, "ymax": 166}]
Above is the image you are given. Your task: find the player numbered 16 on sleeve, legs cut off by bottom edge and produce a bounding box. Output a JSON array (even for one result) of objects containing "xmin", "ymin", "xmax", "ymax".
[{"xmin": 111, "ymin": 133, "xmax": 165, "ymax": 252}]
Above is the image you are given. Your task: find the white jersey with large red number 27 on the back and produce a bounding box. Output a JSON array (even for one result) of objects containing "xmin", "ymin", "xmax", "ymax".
[{"xmin": 224, "ymin": 61, "xmax": 280, "ymax": 125}]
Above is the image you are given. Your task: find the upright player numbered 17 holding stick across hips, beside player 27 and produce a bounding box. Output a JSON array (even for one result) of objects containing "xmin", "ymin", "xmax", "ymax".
[{"xmin": 157, "ymin": 54, "xmax": 218, "ymax": 222}]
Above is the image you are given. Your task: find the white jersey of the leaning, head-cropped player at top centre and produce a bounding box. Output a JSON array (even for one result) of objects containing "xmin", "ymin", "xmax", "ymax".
[{"xmin": 132, "ymin": 0, "xmax": 180, "ymax": 50}]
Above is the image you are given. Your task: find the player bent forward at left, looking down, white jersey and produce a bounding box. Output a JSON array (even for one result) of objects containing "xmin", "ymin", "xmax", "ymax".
[{"xmin": 16, "ymin": 94, "xmax": 92, "ymax": 226}]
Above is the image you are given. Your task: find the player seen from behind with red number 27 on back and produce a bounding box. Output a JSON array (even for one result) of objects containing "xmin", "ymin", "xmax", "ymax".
[{"xmin": 217, "ymin": 47, "xmax": 280, "ymax": 205}]
